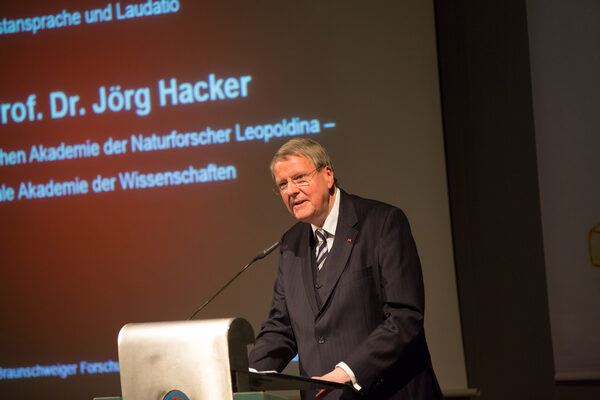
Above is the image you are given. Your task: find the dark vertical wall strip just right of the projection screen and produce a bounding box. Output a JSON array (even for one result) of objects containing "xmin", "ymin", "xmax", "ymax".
[{"xmin": 435, "ymin": 0, "xmax": 600, "ymax": 400}]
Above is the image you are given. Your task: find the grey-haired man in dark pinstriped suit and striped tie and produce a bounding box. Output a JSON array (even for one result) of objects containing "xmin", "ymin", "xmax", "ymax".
[{"xmin": 250, "ymin": 138, "xmax": 442, "ymax": 400}]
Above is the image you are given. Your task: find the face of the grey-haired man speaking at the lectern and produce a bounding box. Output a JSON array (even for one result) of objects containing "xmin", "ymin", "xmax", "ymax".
[{"xmin": 273, "ymin": 155, "xmax": 335, "ymax": 226}]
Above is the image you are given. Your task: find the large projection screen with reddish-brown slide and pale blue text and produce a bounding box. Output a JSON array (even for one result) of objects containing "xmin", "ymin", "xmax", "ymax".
[{"xmin": 0, "ymin": 0, "xmax": 466, "ymax": 399}]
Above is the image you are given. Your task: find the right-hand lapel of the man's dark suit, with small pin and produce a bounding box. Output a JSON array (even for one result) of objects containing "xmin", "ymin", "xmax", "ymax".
[{"xmin": 316, "ymin": 189, "xmax": 358, "ymax": 312}]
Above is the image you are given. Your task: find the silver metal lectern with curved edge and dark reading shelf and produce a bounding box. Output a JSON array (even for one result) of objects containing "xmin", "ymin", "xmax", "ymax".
[{"xmin": 118, "ymin": 318, "xmax": 345, "ymax": 400}]
